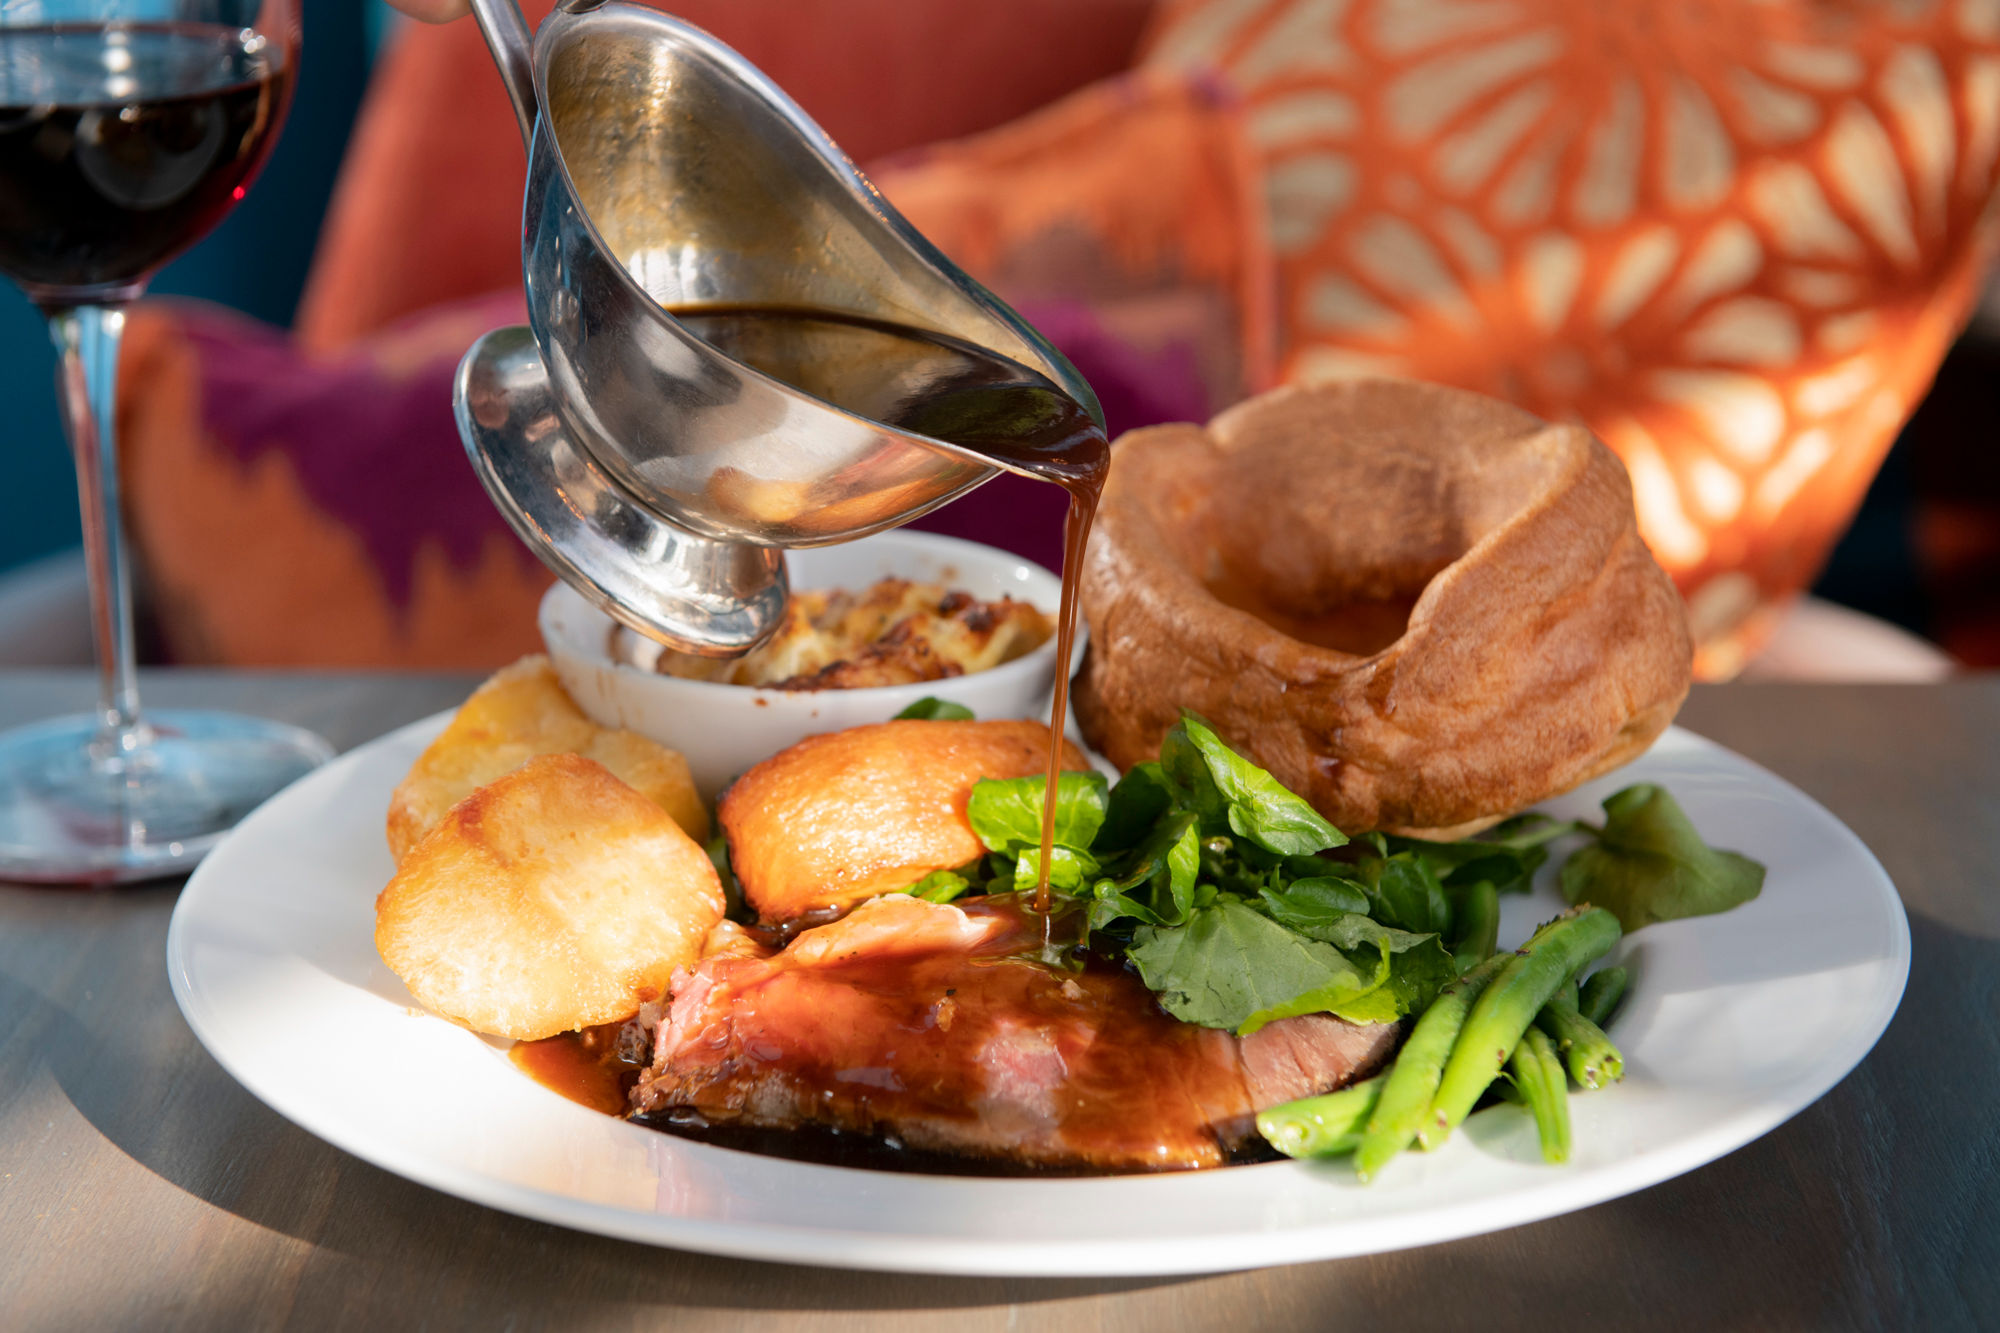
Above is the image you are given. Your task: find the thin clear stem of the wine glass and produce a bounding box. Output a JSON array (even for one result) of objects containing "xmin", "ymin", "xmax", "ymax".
[{"xmin": 48, "ymin": 304, "xmax": 146, "ymax": 767}]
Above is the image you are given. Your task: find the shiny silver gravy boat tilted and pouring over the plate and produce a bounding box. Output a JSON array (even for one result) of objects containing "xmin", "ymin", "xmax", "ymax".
[{"xmin": 456, "ymin": 0, "xmax": 1102, "ymax": 656}]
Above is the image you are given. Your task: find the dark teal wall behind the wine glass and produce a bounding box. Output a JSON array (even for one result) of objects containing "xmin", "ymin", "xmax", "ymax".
[{"xmin": 0, "ymin": 0, "xmax": 382, "ymax": 568}]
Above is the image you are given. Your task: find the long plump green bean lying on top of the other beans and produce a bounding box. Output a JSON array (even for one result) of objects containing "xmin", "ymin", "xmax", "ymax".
[{"xmin": 1424, "ymin": 907, "xmax": 1620, "ymax": 1143}]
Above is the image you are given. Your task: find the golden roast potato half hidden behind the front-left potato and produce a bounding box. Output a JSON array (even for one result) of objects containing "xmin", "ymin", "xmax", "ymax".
[{"xmin": 388, "ymin": 656, "xmax": 708, "ymax": 863}]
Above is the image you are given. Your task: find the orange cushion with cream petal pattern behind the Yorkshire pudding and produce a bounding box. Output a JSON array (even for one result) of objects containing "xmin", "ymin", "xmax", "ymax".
[{"xmin": 1144, "ymin": 0, "xmax": 2000, "ymax": 677}]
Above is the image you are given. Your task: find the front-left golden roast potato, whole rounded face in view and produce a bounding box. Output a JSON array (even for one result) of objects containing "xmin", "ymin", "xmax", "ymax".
[{"xmin": 376, "ymin": 755, "xmax": 724, "ymax": 1041}]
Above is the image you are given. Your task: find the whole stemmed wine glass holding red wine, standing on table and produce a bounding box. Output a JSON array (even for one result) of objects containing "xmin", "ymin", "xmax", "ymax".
[{"xmin": 0, "ymin": 0, "xmax": 332, "ymax": 883}]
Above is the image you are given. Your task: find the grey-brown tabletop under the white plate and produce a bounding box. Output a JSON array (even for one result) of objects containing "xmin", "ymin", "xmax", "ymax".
[{"xmin": 0, "ymin": 673, "xmax": 2000, "ymax": 1333}]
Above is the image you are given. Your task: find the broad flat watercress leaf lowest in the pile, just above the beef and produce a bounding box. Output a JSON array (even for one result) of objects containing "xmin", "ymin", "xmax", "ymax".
[{"xmin": 1128, "ymin": 895, "xmax": 1386, "ymax": 1033}]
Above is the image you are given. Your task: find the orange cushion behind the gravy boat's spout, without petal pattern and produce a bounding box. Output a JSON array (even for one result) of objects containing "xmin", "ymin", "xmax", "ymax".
[{"xmin": 874, "ymin": 72, "xmax": 1272, "ymax": 416}]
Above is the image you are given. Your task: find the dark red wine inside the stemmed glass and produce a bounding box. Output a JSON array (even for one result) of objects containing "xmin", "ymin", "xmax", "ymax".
[{"xmin": 0, "ymin": 24, "xmax": 292, "ymax": 302}]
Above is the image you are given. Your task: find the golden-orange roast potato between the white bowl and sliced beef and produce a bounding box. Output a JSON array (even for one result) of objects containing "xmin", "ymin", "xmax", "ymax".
[{"xmin": 716, "ymin": 721, "xmax": 1090, "ymax": 921}]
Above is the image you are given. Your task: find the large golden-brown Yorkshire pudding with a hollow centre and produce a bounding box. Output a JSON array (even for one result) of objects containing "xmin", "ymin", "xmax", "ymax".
[{"xmin": 1074, "ymin": 380, "xmax": 1692, "ymax": 837}]
